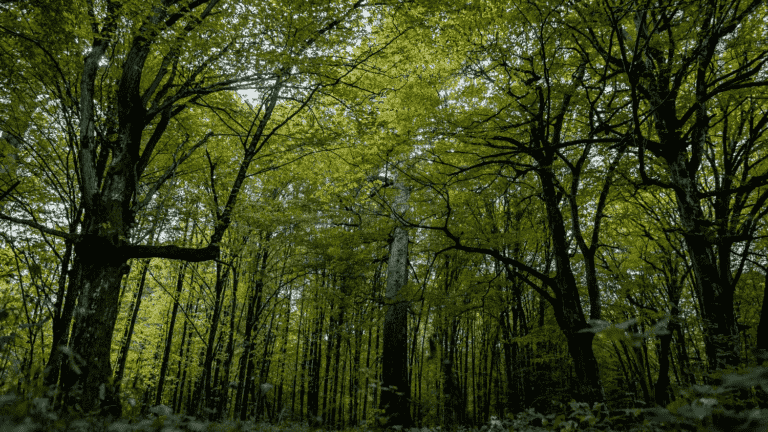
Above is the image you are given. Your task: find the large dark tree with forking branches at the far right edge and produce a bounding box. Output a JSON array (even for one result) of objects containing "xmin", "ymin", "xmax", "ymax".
[{"xmin": 565, "ymin": 1, "xmax": 768, "ymax": 371}]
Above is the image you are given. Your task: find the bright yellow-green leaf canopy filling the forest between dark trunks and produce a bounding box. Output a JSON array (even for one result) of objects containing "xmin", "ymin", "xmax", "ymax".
[{"xmin": 0, "ymin": 0, "xmax": 766, "ymax": 431}]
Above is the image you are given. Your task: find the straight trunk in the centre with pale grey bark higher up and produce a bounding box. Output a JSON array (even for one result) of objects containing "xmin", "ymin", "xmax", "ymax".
[{"xmin": 380, "ymin": 183, "xmax": 412, "ymax": 427}]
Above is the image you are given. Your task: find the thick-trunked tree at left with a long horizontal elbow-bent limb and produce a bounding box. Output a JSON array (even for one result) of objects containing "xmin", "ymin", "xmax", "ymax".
[{"xmin": 2, "ymin": 0, "xmax": 388, "ymax": 414}]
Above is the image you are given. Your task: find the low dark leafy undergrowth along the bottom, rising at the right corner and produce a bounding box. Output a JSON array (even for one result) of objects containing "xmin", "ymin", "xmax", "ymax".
[{"xmin": 0, "ymin": 367, "xmax": 768, "ymax": 432}]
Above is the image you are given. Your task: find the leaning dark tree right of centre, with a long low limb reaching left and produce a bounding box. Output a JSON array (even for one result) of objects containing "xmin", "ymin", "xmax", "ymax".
[{"xmin": 382, "ymin": 2, "xmax": 627, "ymax": 401}]
